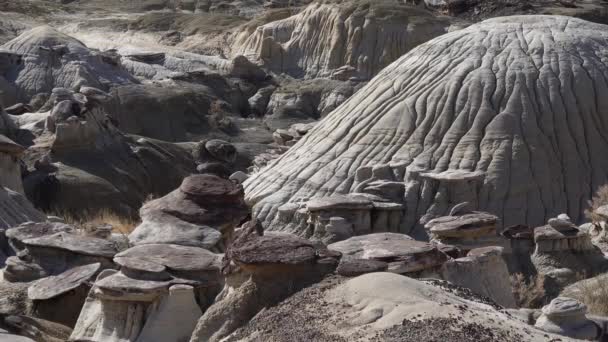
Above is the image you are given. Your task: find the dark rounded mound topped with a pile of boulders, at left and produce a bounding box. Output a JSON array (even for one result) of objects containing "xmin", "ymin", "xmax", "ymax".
[{"xmin": 16, "ymin": 87, "xmax": 196, "ymax": 217}]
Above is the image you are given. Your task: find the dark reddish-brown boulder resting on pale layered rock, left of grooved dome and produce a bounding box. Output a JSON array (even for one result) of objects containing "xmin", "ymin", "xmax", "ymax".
[{"xmin": 129, "ymin": 174, "xmax": 249, "ymax": 250}]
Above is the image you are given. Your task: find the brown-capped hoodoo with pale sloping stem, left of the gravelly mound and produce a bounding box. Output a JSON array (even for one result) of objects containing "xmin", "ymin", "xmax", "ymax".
[{"xmin": 190, "ymin": 221, "xmax": 339, "ymax": 342}]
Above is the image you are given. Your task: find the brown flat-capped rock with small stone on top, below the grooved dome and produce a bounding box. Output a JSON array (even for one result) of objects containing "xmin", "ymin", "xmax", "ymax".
[{"xmin": 425, "ymin": 212, "xmax": 500, "ymax": 250}]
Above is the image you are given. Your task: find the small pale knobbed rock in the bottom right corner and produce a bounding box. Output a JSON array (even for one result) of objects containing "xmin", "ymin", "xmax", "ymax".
[{"xmin": 535, "ymin": 297, "xmax": 601, "ymax": 340}]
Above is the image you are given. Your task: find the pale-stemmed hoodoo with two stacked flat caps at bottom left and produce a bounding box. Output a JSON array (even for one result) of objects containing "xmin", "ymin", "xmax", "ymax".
[{"xmin": 69, "ymin": 244, "xmax": 221, "ymax": 342}]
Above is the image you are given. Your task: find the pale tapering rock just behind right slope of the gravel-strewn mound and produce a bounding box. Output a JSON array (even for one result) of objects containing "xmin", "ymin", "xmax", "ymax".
[{"xmin": 441, "ymin": 247, "xmax": 517, "ymax": 308}]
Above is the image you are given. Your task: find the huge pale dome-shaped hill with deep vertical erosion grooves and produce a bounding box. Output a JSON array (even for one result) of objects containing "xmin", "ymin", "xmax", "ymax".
[{"xmin": 245, "ymin": 16, "xmax": 608, "ymax": 237}]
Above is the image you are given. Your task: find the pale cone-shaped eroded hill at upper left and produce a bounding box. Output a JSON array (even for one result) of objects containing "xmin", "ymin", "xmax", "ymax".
[{"xmin": 2, "ymin": 26, "xmax": 137, "ymax": 104}]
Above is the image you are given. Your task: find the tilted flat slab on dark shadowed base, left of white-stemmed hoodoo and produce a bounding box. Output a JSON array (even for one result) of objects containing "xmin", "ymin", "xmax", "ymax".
[{"xmin": 27, "ymin": 263, "xmax": 101, "ymax": 327}]
